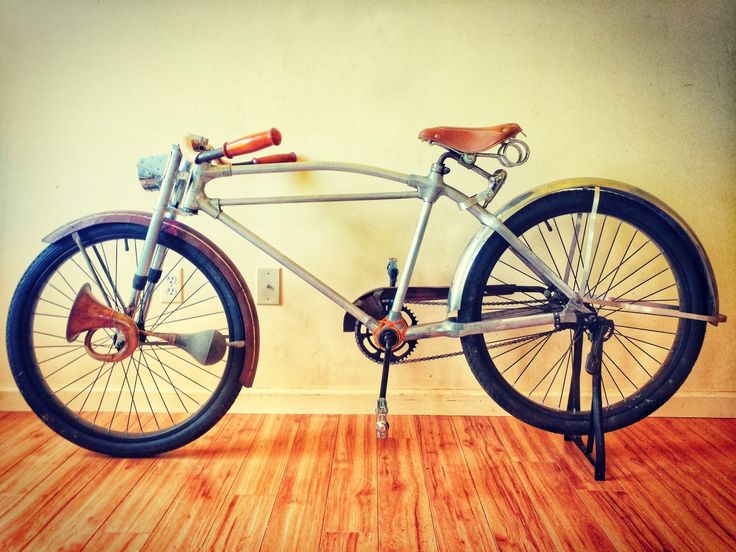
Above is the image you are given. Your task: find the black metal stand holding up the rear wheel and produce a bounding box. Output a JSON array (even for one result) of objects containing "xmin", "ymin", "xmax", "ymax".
[{"xmin": 565, "ymin": 318, "xmax": 613, "ymax": 481}]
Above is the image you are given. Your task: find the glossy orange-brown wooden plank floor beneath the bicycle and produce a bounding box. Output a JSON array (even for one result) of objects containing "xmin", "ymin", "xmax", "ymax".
[{"xmin": 0, "ymin": 412, "xmax": 736, "ymax": 551}]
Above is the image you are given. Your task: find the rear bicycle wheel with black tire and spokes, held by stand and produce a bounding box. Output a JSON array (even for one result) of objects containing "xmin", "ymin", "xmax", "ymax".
[{"xmin": 458, "ymin": 190, "xmax": 707, "ymax": 435}]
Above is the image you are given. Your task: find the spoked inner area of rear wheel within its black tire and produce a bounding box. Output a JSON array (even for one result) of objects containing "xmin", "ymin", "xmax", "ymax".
[{"xmin": 483, "ymin": 206, "xmax": 683, "ymax": 415}]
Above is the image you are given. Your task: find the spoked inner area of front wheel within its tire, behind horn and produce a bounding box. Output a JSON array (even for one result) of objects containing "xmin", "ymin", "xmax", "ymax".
[{"xmin": 28, "ymin": 230, "xmax": 239, "ymax": 440}]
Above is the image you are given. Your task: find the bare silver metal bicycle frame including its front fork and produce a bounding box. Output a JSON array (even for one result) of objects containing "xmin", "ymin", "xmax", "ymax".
[{"xmin": 127, "ymin": 146, "xmax": 576, "ymax": 339}]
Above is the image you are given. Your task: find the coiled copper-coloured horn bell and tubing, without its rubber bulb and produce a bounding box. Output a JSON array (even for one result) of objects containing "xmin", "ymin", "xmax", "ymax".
[{"xmin": 66, "ymin": 284, "xmax": 139, "ymax": 362}]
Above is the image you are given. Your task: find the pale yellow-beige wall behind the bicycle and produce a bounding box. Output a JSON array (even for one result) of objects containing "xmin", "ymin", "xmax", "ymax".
[{"xmin": 0, "ymin": 0, "xmax": 736, "ymax": 415}]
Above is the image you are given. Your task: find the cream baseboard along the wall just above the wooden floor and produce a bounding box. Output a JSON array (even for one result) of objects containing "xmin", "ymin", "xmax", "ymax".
[{"xmin": 0, "ymin": 387, "xmax": 736, "ymax": 418}]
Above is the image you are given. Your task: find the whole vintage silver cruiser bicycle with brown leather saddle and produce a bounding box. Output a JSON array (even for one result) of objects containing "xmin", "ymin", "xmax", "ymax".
[{"xmin": 7, "ymin": 124, "xmax": 725, "ymax": 478}]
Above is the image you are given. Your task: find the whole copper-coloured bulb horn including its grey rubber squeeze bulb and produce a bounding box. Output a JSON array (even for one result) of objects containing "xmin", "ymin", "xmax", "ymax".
[{"xmin": 66, "ymin": 284, "xmax": 231, "ymax": 365}]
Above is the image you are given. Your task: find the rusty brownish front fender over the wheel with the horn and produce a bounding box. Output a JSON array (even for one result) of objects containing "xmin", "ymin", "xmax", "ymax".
[{"xmin": 43, "ymin": 211, "xmax": 260, "ymax": 387}]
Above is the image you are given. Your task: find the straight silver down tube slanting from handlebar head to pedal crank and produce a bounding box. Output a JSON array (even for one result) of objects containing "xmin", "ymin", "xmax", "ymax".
[{"xmin": 199, "ymin": 201, "xmax": 378, "ymax": 330}]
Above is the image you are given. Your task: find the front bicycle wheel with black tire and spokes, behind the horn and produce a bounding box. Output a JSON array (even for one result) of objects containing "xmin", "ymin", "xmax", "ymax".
[{"xmin": 7, "ymin": 223, "xmax": 247, "ymax": 457}]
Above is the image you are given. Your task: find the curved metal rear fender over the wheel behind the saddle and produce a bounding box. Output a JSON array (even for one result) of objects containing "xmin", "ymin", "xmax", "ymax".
[{"xmin": 448, "ymin": 178, "xmax": 719, "ymax": 324}]
